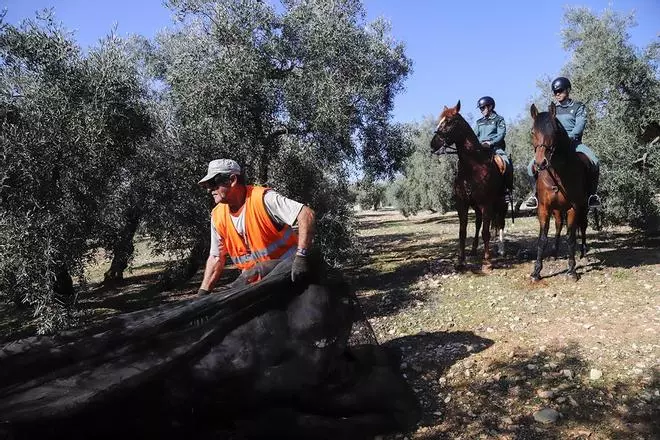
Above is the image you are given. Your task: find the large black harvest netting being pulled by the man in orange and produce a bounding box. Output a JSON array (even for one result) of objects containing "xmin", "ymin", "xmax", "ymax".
[{"xmin": 0, "ymin": 260, "xmax": 417, "ymax": 439}]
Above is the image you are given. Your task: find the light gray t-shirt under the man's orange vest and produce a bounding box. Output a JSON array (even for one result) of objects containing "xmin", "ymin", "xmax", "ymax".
[{"xmin": 209, "ymin": 190, "xmax": 304, "ymax": 257}]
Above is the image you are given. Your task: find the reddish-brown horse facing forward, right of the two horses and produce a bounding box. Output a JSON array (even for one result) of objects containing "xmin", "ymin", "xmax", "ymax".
[{"xmin": 530, "ymin": 103, "xmax": 589, "ymax": 281}]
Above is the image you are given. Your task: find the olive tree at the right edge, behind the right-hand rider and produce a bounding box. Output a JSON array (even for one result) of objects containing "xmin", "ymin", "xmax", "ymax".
[{"xmin": 562, "ymin": 8, "xmax": 660, "ymax": 230}]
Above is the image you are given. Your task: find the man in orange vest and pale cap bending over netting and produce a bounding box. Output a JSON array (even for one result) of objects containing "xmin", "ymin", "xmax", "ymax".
[{"xmin": 198, "ymin": 159, "xmax": 315, "ymax": 295}]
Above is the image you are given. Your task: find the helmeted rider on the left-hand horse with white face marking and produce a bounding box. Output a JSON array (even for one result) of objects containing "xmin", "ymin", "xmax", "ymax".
[{"xmin": 472, "ymin": 96, "xmax": 513, "ymax": 199}]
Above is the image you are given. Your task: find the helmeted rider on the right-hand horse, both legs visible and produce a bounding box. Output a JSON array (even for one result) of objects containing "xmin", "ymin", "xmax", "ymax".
[{"xmin": 525, "ymin": 76, "xmax": 600, "ymax": 208}]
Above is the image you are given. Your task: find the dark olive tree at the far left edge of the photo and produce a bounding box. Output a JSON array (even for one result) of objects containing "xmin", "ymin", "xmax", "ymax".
[{"xmin": 0, "ymin": 13, "xmax": 150, "ymax": 333}]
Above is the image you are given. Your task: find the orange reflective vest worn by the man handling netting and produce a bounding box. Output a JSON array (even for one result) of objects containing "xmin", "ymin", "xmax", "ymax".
[{"xmin": 211, "ymin": 185, "xmax": 298, "ymax": 270}]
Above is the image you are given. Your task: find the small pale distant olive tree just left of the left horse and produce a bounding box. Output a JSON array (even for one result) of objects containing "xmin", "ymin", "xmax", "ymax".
[{"xmin": 393, "ymin": 118, "xmax": 457, "ymax": 216}]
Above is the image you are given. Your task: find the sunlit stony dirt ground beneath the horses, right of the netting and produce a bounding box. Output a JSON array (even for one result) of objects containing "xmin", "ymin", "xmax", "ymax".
[{"xmin": 349, "ymin": 210, "xmax": 660, "ymax": 439}]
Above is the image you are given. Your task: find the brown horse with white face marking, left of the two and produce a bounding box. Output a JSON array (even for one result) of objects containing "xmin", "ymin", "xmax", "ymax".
[{"xmin": 431, "ymin": 101, "xmax": 506, "ymax": 271}]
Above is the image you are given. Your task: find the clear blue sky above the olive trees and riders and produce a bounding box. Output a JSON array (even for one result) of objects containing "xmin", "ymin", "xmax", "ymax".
[{"xmin": 0, "ymin": 0, "xmax": 660, "ymax": 122}]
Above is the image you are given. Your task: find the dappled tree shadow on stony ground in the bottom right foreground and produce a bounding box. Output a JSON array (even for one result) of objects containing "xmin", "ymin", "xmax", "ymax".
[{"xmin": 395, "ymin": 340, "xmax": 660, "ymax": 440}]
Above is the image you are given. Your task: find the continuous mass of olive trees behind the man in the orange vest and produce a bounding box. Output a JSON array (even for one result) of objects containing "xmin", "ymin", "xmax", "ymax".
[{"xmin": 0, "ymin": 0, "xmax": 411, "ymax": 333}]
